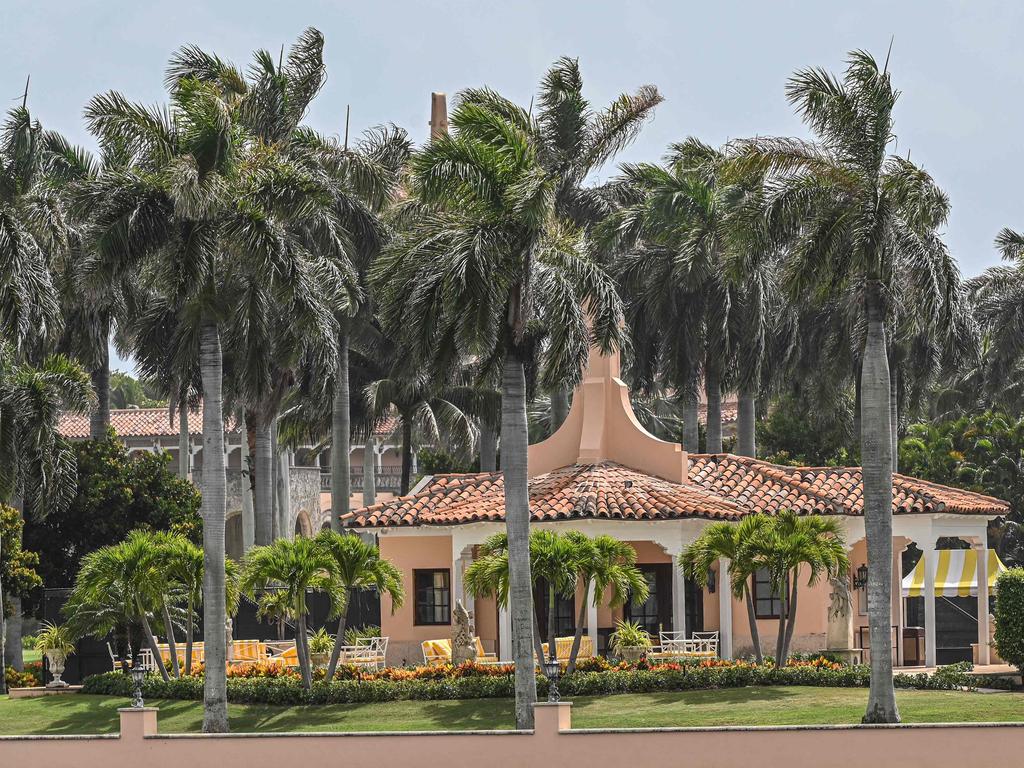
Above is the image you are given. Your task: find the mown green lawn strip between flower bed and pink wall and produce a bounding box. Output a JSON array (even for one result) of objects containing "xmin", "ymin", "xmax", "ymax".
[{"xmin": 0, "ymin": 687, "xmax": 1024, "ymax": 735}]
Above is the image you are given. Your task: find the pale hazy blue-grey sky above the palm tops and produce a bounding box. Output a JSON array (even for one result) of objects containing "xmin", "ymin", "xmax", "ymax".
[{"xmin": 0, "ymin": 0, "xmax": 1024, "ymax": 367}]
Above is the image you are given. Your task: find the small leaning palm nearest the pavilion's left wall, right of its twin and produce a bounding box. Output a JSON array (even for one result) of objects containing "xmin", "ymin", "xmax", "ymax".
[{"xmin": 316, "ymin": 530, "xmax": 406, "ymax": 683}]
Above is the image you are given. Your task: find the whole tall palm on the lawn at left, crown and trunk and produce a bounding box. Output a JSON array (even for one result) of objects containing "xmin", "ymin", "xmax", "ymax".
[{"xmin": 86, "ymin": 32, "xmax": 343, "ymax": 732}]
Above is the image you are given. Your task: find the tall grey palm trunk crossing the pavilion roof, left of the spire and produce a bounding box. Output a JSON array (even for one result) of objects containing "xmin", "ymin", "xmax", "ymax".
[{"xmin": 502, "ymin": 352, "xmax": 537, "ymax": 729}]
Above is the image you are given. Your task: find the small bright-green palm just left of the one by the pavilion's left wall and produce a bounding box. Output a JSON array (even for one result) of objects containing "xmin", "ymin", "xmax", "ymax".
[{"xmin": 241, "ymin": 537, "xmax": 345, "ymax": 690}]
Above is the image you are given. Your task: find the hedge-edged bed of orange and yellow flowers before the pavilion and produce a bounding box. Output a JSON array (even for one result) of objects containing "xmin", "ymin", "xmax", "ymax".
[{"xmin": 83, "ymin": 658, "xmax": 970, "ymax": 705}]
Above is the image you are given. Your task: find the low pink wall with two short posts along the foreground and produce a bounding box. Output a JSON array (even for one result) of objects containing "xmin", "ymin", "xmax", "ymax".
[{"xmin": 0, "ymin": 702, "xmax": 1024, "ymax": 768}]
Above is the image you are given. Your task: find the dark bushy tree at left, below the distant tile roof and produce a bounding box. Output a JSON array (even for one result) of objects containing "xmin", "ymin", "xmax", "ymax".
[{"xmin": 25, "ymin": 431, "xmax": 203, "ymax": 587}]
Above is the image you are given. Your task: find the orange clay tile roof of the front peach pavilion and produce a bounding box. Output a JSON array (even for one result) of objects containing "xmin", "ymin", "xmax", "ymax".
[{"xmin": 346, "ymin": 455, "xmax": 1009, "ymax": 527}]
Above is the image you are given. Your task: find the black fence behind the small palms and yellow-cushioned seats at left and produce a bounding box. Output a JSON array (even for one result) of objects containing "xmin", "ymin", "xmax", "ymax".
[{"xmin": 43, "ymin": 589, "xmax": 381, "ymax": 685}]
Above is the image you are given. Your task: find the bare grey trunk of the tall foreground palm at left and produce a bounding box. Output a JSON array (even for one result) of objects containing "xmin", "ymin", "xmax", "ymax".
[{"xmin": 200, "ymin": 323, "xmax": 228, "ymax": 733}]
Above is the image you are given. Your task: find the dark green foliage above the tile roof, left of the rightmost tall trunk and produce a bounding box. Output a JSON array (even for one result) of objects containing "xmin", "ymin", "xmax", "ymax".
[{"xmin": 758, "ymin": 394, "xmax": 859, "ymax": 467}]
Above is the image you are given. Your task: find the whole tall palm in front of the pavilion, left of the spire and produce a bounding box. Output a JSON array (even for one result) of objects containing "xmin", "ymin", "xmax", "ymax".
[{"xmin": 372, "ymin": 89, "xmax": 622, "ymax": 728}]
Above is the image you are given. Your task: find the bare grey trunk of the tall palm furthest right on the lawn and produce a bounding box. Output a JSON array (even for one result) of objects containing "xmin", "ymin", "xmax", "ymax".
[{"xmin": 860, "ymin": 280, "xmax": 899, "ymax": 723}]
